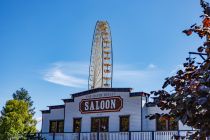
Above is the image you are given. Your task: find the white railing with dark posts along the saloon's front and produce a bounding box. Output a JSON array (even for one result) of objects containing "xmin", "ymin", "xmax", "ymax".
[{"xmin": 28, "ymin": 131, "xmax": 210, "ymax": 140}]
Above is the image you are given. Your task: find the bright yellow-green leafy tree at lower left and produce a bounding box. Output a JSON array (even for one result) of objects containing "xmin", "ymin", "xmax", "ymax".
[{"xmin": 0, "ymin": 100, "xmax": 36, "ymax": 140}]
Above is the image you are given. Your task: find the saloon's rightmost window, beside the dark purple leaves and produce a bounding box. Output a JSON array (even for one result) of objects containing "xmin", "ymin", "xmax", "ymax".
[{"xmin": 156, "ymin": 117, "xmax": 178, "ymax": 131}]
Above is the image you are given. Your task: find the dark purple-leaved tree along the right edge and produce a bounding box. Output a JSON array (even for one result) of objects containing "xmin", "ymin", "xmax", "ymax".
[{"xmin": 147, "ymin": 1, "xmax": 210, "ymax": 139}]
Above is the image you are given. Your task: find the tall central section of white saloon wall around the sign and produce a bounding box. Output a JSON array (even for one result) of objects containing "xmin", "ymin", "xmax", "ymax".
[{"xmin": 64, "ymin": 92, "xmax": 141, "ymax": 132}]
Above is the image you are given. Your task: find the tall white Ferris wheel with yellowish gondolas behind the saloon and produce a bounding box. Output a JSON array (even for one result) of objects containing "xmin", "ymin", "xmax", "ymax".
[{"xmin": 88, "ymin": 21, "xmax": 113, "ymax": 89}]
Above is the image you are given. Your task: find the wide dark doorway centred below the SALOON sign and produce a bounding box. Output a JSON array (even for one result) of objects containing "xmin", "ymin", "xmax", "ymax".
[{"xmin": 91, "ymin": 117, "xmax": 109, "ymax": 132}]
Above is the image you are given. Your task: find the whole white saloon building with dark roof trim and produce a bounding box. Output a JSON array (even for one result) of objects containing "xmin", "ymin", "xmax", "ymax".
[{"xmin": 41, "ymin": 88, "xmax": 192, "ymax": 137}]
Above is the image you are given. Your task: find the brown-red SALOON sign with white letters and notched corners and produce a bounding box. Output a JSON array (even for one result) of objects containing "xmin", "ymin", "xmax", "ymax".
[{"xmin": 79, "ymin": 96, "xmax": 123, "ymax": 114}]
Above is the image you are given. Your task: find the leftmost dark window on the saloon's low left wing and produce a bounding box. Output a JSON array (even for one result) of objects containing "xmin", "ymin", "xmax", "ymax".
[{"xmin": 50, "ymin": 120, "xmax": 64, "ymax": 133}]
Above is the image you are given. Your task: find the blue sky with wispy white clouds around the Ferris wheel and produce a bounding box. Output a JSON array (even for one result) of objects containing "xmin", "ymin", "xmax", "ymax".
[{"xmin": 0, "ymin": 0, "xmax": 207, "ymax": 130}]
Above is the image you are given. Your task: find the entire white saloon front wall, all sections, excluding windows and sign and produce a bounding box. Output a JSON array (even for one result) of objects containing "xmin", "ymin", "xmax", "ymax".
[{"xmin": 42, "ymin": 89, "xmax": 191, "ymax": 132}]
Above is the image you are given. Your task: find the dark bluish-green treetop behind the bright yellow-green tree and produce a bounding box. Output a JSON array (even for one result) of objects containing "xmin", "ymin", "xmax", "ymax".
[{"xmin": 12, "ymin": 88, "xmax": 35, "ymax": 115}]
